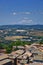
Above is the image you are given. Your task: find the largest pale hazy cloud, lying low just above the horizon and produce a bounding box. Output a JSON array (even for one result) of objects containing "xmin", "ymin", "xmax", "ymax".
[{"xmin": 9, "ymin": 17, "xmax": 33, "ymax": 25}]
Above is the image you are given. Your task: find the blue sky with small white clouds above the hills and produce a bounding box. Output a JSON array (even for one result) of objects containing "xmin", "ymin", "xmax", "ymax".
[{"xmin": 0, "ymin": 0, "xmax": 43, "ymax": 25}]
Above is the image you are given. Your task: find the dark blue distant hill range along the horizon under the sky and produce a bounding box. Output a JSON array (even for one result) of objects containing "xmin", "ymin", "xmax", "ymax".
[{"xmin": 0, "ymin": 25, "xmax": 43, "ymax": 30}]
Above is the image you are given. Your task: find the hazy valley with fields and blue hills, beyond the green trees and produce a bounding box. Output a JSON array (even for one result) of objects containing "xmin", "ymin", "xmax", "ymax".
[{"xmin": 0, "ymin": 25, "xmax": 43, "ymax": 43}]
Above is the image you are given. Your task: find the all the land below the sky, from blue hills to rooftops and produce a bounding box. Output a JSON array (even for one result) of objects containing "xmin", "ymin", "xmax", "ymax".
[{"xmin": 0, "ymin": 25, "xmax": 43, "ymax": 65}]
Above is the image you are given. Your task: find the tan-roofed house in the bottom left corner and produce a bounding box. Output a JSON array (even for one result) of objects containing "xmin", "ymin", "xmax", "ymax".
[{"xmin": 0, "ymin": 54, "xmax": 12, "ymax": 65}]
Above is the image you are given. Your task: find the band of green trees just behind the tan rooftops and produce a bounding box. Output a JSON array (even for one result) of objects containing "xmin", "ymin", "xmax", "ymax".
[{"xmin": 0, "ymin": 40, "xmax": 31, "ymax": 53}]
